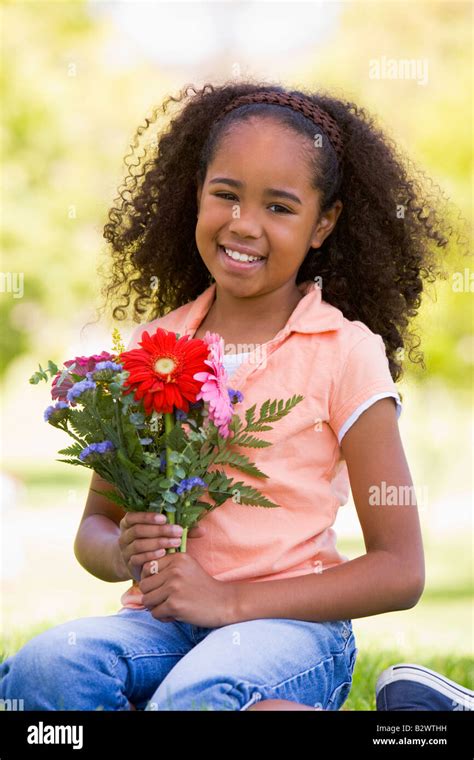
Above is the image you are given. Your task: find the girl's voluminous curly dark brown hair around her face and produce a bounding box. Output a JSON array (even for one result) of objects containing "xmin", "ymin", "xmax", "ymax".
[{"xmin": 98, "ymin": 79, "xmax": 459, "ymax": 382}]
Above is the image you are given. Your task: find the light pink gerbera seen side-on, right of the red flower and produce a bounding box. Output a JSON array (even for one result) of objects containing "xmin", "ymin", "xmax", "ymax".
[{"xmin": 193, "ymin": 330, "xmax": 233, "ymax": 438}]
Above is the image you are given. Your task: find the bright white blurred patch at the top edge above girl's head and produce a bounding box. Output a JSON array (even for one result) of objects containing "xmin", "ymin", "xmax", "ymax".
[{"xmin": 89, "ymin": 0, "xmax": 343, "ymax": 70}]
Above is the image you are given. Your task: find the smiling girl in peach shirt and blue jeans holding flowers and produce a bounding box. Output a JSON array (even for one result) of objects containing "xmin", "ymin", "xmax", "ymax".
[{"xmin": 1, "ymin": 82, "xmax": 462, "ymax": 710}]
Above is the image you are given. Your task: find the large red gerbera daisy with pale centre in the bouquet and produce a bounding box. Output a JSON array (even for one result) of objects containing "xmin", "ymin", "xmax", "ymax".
[{"xmin": 118, "ymin": 327, "xmax": 209, "ymax": 414}]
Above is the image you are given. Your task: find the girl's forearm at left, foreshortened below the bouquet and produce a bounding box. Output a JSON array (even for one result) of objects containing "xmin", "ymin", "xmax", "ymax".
[{"xmin": 74, "ymin": 515, "xmax": 133, "ymax": 583}]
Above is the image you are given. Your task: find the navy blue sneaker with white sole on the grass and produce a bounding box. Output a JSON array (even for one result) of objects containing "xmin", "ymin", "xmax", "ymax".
[{"xmin": 375, "ymin": 663, "xmax": 474, "ymax": 712}]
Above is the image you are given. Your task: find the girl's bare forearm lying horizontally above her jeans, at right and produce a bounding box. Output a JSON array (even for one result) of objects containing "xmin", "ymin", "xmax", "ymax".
[{"xmin": 229, "ymin": 551, "xmax": 421, "ymax": 623}]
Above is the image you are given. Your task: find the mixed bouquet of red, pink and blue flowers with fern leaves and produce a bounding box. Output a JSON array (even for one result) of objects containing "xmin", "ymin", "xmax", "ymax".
[{"xmin": 30, "ymin": 328, "xmax": 303, "ymax": 552}]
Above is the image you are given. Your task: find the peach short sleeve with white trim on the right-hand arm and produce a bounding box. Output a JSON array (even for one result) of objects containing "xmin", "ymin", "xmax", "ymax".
[{"xmin": 329, "ymin": 333, "xmax": 403, "ymax": 443}]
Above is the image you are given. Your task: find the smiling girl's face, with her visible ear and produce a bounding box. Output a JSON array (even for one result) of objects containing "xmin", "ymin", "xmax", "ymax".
[{"xmin": 196, "ymin": 118, "xmax": 342, "ymax": 297}]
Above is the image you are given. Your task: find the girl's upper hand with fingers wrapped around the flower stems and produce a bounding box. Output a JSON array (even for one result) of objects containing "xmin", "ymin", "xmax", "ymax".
[{"xmin": 118, "ymin": 512, "xmax": 206, "ymax": 581}]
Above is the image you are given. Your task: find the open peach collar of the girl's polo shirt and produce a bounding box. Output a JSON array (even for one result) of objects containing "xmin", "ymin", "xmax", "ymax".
[{"xmin": 183, "ymin": 280, "xmax": 344, "ymax": 336}]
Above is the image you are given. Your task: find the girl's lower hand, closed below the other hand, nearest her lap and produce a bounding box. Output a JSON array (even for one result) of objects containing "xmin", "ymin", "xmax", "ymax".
[{"xmin": 139, "ymin": 552, "xmax": 236, "ymax": 628}]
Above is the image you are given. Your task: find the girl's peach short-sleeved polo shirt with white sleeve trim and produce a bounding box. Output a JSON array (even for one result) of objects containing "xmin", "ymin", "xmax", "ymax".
[{"xmin": 117, "ymin": 280, "xmax": 402, "ymax": 607}]
